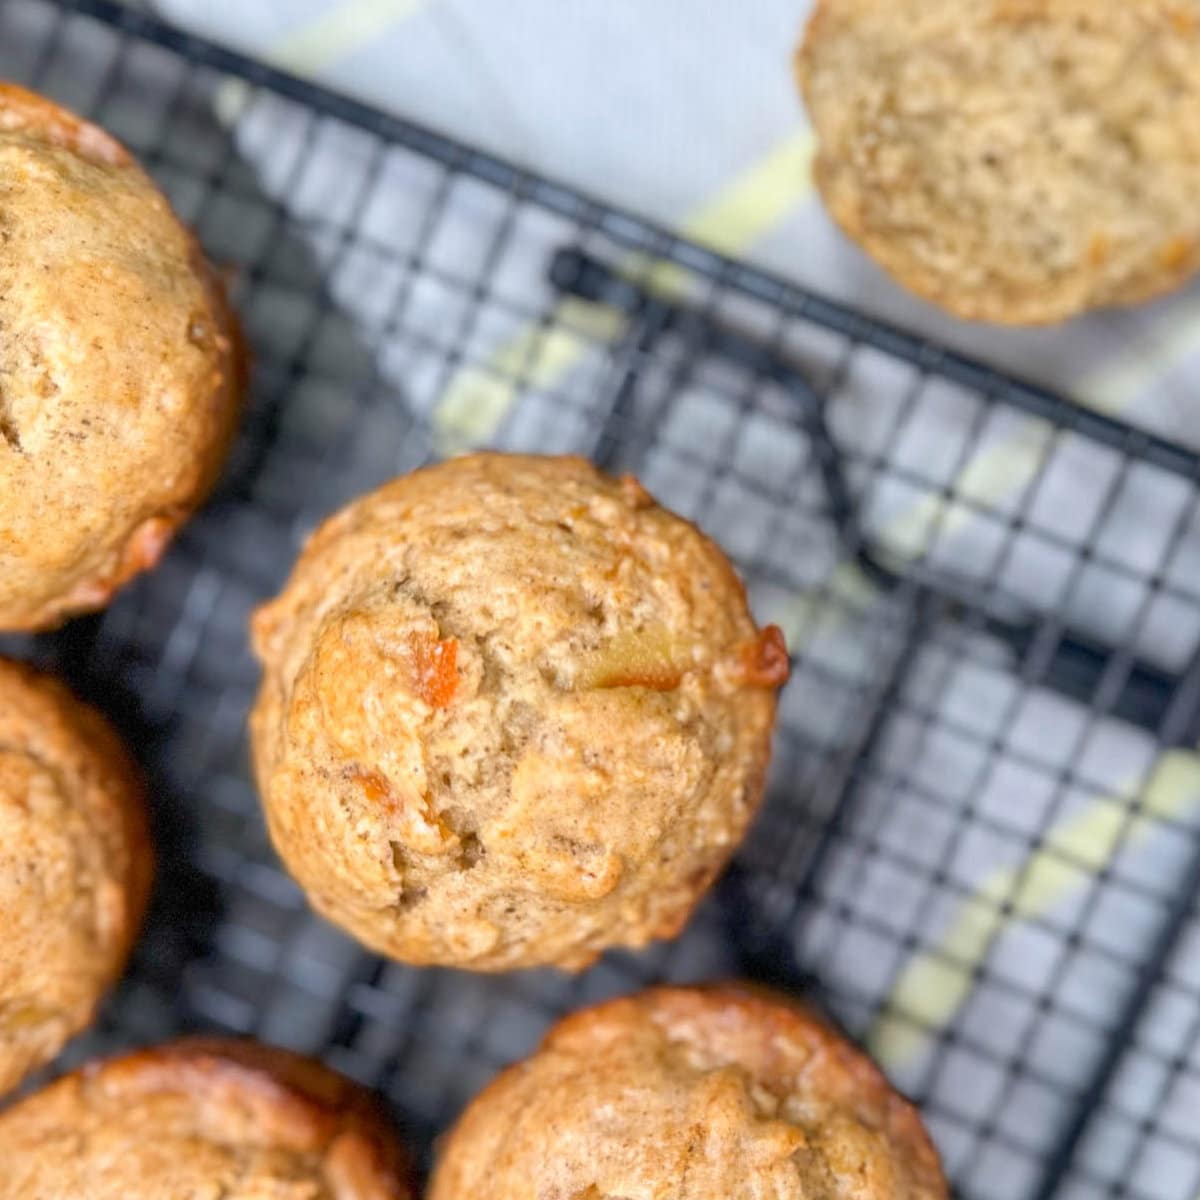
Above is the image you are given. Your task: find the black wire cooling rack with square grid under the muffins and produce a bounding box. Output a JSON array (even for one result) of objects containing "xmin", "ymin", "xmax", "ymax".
[{"xmin": 0, "ymin": 0, "xmax": 1200, "ymax": 1200}]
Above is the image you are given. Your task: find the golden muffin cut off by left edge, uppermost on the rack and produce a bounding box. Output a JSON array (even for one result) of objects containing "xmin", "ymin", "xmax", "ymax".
[{"xmin": 0, "ymin": 84, "xmax": 241, "ymax": 630}]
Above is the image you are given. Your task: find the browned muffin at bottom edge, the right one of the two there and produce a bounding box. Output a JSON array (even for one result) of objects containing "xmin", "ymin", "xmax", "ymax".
[{"xmin": 430, "ymin": 986, "xmax": 948, "ymax": 1200}]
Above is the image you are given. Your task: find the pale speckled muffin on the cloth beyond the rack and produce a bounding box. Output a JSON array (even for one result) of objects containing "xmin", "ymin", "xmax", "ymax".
[{"xmin": 797, "ymin": 0, "xmax": 1200, "ymax": 324}]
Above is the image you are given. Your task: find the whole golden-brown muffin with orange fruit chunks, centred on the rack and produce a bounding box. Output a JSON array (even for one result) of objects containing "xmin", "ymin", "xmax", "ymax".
[{"xmin": 251, "ymin": 454, "xmax": 787, "ymax": 971}]
